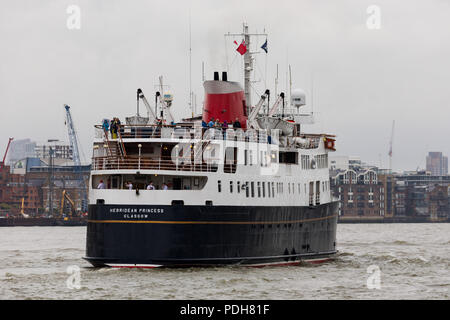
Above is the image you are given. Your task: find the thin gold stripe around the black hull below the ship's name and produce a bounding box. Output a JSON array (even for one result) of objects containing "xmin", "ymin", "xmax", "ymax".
[{"xmin": 88, "ymin": 214, "xmax": 337, "ymax": 224}]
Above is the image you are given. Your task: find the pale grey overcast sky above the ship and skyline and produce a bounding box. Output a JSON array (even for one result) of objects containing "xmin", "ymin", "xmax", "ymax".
[{"xmin": 0, "ymin": 0, "xmax": 450, "ymax": 170}]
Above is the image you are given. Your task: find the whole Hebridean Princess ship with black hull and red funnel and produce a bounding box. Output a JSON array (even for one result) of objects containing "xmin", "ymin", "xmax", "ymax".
[{"xmin": 84, "ymin": 25, "xmax": 338, "ymax": 268}]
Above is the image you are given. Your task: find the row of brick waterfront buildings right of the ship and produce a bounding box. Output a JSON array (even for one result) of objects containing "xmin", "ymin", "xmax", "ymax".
[{"xmin": 331, "ymin": 166, "xmax": 450, "ymax": 222}]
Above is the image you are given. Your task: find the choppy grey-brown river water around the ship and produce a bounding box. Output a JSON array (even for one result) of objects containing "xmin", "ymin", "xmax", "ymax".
[{"xmin": 0, "ymin": 224, "xmax": 450, "ymax": 300}]
